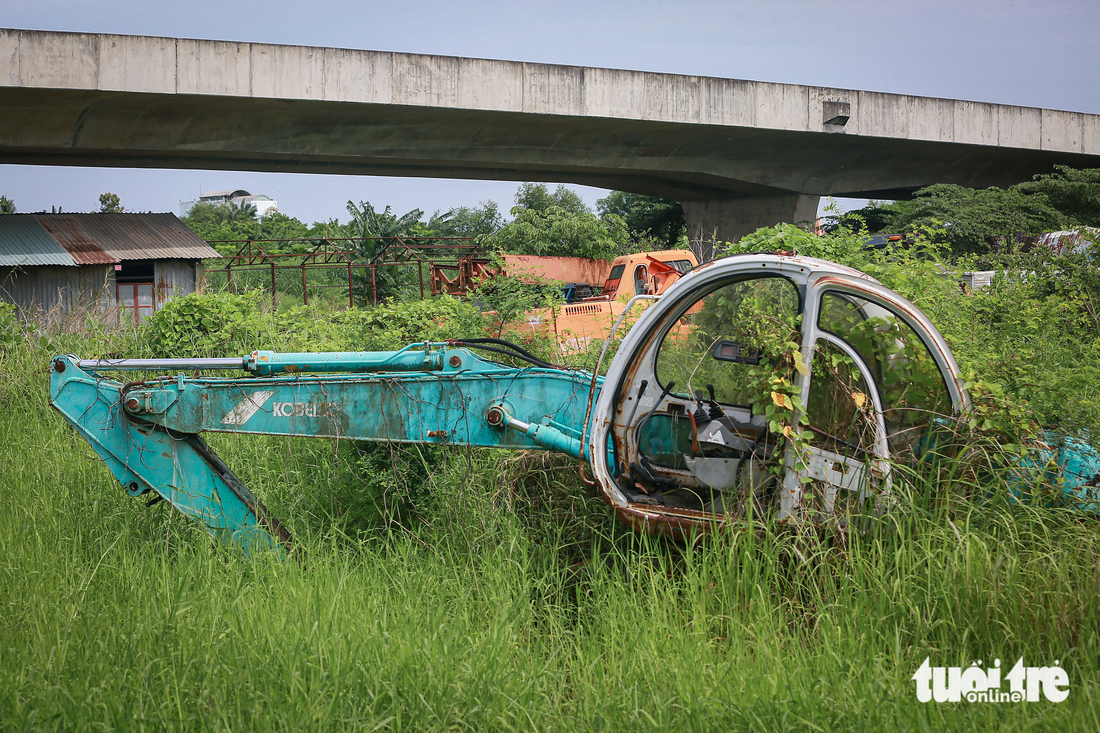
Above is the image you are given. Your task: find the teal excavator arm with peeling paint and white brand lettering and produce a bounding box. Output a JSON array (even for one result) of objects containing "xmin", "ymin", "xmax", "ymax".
[{"xmin": 50, "ymin": 343, "xmax": 601, "ymax": 551}]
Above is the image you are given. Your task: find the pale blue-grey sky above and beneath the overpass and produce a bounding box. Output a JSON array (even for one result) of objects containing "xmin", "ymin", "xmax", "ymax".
[{"xmin": 0, "ymin": 0, "xmax": 1100, "ymax": 222}]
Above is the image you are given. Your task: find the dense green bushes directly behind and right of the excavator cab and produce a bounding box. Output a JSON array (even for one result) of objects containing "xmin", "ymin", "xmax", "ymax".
[{"xmin": 728, "ymin": 225, "xmax": 1100, "ymax": 444}]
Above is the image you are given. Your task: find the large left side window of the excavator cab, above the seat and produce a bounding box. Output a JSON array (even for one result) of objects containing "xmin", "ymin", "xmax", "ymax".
[{"xmin": 657, "ymin": 276, "xmax": 800, "ymax": 407}]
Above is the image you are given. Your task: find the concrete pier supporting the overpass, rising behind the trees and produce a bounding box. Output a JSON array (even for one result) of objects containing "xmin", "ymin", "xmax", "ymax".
[{"xmin": 682, "ymin": 194, "xmax": 821, "ymax": 253}]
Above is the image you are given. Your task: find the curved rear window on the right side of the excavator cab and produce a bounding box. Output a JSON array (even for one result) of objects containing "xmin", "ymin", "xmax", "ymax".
[{"xmin": 815, "ymin": 292, "xmax": 952, "ymax": 455}]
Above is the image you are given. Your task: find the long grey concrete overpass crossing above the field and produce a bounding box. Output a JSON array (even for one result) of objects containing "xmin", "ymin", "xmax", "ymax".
[{"xmin": 0, "ymin": 30, "xmax": 1100, "ymax": 239}]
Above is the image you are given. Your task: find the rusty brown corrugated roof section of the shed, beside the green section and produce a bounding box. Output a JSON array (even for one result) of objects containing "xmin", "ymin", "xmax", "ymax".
[{"xmin": 37, "ymin": 214, "xmax": 221, "ymax": 262}]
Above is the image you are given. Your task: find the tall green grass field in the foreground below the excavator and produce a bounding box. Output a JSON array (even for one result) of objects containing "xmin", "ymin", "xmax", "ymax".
[{"xmin": 0, "ymin": 312, "xmax": 1100, "ymax": 731}]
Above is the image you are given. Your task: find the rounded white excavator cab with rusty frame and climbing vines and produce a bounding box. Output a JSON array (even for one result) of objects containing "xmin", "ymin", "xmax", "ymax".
[{"xmin": 591, "ymin": 254, "xmax": 968, "ymax": 533}]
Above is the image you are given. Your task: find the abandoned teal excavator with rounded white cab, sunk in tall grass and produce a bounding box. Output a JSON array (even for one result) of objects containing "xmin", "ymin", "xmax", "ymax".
[{"xmin": 50, "ymin": 253, "xmax": 1100, "ymax": 551}]
